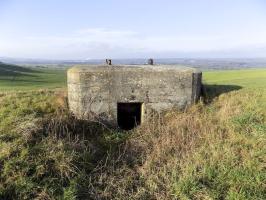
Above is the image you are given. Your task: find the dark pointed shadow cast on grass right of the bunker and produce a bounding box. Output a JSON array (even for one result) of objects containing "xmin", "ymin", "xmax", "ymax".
[{"xmin": 202, "ymin": 84, "xmax": 242, "ymax": 102}]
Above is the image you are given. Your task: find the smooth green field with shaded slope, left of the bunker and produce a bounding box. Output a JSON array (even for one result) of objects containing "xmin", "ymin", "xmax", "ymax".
[{"xmin": 0, "ymin": 63, "xmax": 66, "ymax": 91}]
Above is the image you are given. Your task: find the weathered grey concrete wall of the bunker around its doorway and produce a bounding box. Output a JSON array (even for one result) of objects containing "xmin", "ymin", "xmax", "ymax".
[{"xmin": 67, "ymin": 65, "xmax": 201, "ymax": 123}]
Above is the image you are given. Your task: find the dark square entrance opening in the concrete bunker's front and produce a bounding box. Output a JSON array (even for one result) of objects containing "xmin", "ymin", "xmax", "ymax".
[{"xmin": 117, "ymin": 103, "xmax": 142, "ymax": 130}]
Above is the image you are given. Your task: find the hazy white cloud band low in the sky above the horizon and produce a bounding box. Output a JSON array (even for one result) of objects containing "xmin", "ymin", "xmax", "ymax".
[{"xmin": 0, "ymin": 28, "xmax": 266, "ymax": 59}]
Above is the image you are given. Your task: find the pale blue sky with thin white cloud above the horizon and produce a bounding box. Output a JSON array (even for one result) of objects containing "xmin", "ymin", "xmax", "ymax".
[{"xmin": 0, "ymin": 0, "xmax": 266, "ymax": 60}]
